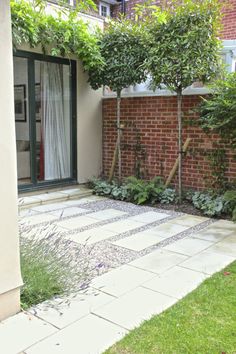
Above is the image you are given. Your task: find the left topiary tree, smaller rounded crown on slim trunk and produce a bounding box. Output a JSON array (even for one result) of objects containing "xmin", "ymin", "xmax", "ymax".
[{"xmin": 89, "ymin": 19, "xmax": 147, "ymax": 182}]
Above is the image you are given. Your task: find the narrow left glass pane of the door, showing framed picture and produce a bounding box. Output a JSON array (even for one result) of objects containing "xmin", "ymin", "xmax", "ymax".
[{"xmin": 14, "ymin": 57, "xmax": 31, "ymax": 184}]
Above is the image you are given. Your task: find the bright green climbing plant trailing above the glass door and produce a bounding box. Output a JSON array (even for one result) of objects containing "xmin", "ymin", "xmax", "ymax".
[{"xmin": 10, "ymin": 0, "xmax": 103, "ymax": 70}]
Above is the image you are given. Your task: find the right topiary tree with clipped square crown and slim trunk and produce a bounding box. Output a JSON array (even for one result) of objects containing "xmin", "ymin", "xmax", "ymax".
[{"xmin": 147, "ymin": 0, "xmax": 220, "ymax": 202}]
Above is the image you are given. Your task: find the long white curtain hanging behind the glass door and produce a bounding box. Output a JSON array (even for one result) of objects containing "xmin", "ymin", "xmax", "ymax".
[{"xmin": 41, "ymin": 62, "xmax": 70, "ymax": 180}]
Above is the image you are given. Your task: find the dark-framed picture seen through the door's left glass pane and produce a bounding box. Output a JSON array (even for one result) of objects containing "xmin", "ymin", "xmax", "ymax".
[{"xmin": 14, "ymin": 85, "xmax": 26, "ymax": 122}]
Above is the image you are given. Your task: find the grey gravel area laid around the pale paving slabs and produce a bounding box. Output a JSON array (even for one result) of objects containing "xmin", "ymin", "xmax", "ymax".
[{"xmin": 21, "ymin": 199, "xmax": 217, "ymax": 280}]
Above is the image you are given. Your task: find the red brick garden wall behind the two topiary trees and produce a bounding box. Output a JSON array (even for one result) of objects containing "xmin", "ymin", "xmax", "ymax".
[{"xmin": 103, "ymin": 96, "xmax": 236, "ymax": 189}]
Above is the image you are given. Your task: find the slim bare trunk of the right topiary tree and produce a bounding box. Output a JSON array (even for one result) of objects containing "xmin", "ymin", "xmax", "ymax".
[{"xmin": 177, "ymin": 89, "xmax": 183, "ymax": 203}]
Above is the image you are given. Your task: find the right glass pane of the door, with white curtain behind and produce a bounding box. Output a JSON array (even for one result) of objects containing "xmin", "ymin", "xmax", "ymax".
[{"xmin": 35, "ymin": 61, "xmax": 71, "ymax": 181}]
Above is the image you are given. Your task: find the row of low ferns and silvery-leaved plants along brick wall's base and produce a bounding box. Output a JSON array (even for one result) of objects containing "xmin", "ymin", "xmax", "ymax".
[{"xmin": 90, "ymin": 177, "xmax": 236, "ymax": 221}]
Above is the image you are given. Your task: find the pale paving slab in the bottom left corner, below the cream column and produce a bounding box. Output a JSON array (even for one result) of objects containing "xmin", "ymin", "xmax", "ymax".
[{"xmin": 0, "ymin": 312, "xmax": 57, "ymax": 354}]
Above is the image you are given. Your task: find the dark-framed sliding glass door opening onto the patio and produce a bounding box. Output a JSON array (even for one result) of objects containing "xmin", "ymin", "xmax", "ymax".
[{"xmin": 14, "ymin": 52, "xmax": 76, "ymax": 189}]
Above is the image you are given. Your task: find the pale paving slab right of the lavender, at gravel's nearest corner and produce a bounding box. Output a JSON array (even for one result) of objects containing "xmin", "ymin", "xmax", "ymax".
[{"xmin": 91, "ymin": 265, "xmax": 155, "ymax": 296}]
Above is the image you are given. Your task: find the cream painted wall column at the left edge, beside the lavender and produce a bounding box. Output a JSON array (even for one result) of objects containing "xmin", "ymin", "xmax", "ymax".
[{"xmin": 0, "ymin": 0, "xmax": 22, "ymax": 320}]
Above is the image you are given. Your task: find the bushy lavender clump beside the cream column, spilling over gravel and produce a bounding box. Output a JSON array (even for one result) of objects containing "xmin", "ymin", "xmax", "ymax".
[{"xmin": 20, "ymin": 227, "xmax": 91, "ymax": 309}]
